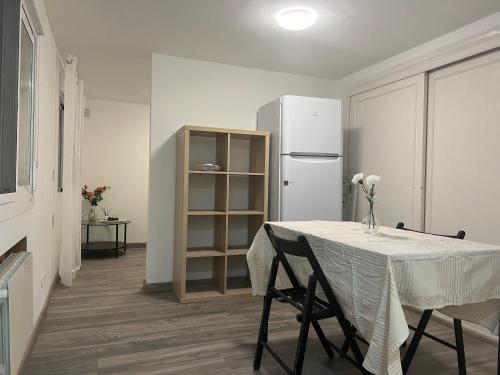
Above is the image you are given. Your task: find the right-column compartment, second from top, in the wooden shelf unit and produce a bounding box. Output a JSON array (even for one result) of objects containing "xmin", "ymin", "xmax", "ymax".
[{"xmin": 229, "ymin": 174, "xmax": 265, "ymax": 212}]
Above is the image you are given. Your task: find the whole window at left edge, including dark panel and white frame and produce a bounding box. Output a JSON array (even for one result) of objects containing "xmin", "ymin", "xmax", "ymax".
[{"xmin": 0, "ymin": 0, "xmax": 36, "ymax": 204}]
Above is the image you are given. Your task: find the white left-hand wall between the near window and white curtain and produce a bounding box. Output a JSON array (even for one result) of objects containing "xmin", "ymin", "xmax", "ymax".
[{"xmin": 0, "ymin": 1, "xmax": 59, "ymax": 321}]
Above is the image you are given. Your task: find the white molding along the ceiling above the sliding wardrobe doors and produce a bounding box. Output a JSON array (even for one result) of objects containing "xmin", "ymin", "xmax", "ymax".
[{"xmin": 341, "ymin": 12, "xmax": 500, "ymax": 96}]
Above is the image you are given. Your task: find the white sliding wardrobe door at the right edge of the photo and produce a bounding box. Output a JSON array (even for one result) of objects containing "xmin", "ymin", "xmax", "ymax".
[{"xmin": 425, "ymin": 52, "xmax": 500, "ymax": 244}]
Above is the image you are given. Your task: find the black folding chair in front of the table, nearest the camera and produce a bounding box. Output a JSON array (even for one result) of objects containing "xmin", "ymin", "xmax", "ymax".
[{"xmin": 254, "ymin": 224, "xmax": 369, "ymax": 375}]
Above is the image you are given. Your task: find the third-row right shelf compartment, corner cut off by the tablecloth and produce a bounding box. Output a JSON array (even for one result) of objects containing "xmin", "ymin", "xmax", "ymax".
[{"xmin": 227, "ymin": 215, "xmax": 264, "ymax": 251}]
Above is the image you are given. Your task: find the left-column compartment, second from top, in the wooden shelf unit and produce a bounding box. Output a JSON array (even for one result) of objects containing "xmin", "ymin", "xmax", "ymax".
[{"xmin": 188, "ymin": 173, "xmax": 228, "ymax": 212}]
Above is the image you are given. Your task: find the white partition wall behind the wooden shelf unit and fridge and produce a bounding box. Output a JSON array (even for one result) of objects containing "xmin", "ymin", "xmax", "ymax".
[{"xmin": 146, "ymin": 54, "xmax": 338, "ymax": 283}]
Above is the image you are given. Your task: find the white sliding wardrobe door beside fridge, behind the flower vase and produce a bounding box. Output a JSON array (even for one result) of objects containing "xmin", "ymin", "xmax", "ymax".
[{"xmin": 349, "ymin": 74, "xmax": 425, "ymax": 229}]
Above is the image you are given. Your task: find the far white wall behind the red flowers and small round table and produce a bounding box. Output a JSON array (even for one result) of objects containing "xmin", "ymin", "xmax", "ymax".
[{"xmin": 82, "ymin": 99, "xmax": 149, "ymax": 243}]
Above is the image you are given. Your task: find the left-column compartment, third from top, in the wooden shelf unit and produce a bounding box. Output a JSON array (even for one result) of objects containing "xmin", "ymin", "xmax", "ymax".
[{"xmin": 186, "ymin": 215, "xmax": 227, "ymax": 253}]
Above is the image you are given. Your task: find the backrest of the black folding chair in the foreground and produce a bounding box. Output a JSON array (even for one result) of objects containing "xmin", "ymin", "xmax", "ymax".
[{"xmin": 264, "ymin": 223, "xmax": 338, "ymax": 306}]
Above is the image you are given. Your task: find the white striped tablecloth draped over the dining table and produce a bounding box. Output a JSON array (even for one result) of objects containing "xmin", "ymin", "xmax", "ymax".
[{"xmin": 247, "ymin": 221, "xmax": 500, "ymax": 375}]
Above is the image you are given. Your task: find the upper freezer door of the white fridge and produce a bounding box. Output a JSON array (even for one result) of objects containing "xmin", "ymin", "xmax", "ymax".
[{"xmin": 281, "ymin": 95, "xmax": 342, "ymax": 155}]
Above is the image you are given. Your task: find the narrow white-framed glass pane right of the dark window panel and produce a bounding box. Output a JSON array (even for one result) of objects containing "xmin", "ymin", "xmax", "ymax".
[{"xmin": 17, "ymin": 12, "xmax": 35, "ymax": 189}]
